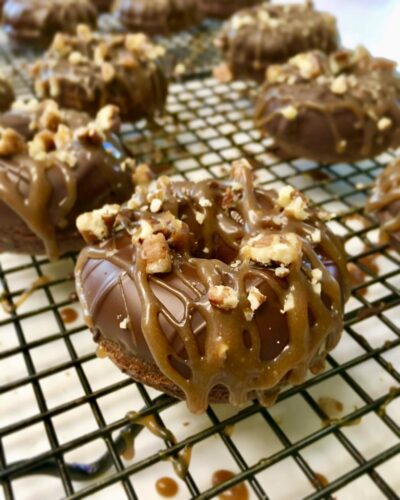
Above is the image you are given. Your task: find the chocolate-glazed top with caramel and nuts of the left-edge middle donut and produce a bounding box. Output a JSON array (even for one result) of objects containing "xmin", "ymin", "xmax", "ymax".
[{"xmin": 0, "ymin": 101, "xmax": 132, "ymax": 259}]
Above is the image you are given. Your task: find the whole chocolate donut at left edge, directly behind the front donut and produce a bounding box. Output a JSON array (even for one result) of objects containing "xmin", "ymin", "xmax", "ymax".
[{"xmin": 0, "ymin": 101, "xmax": 133, "ymax": 259}]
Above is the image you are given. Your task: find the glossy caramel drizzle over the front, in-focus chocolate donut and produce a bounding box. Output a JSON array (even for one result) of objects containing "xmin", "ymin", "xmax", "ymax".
[{"xmin": 76, "ymin": 168, "xmax": 347, "ymax": 413}]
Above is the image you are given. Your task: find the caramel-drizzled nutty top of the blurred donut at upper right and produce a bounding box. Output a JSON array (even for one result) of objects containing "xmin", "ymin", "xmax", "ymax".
[{"xmin": 256, "ymin": 47, "xmax": 400, "ymax": 156}]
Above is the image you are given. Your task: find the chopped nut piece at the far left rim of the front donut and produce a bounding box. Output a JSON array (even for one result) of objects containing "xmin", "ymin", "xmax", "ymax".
[{"xmin": 76, "ymin": 204, "xmax": 121, "ymax": 245}]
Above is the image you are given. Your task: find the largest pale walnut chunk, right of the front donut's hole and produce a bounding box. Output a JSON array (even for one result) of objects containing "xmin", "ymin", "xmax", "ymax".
[{"xmin": 241, "ymin": 233, "xmax": 302, "ymax": 266}]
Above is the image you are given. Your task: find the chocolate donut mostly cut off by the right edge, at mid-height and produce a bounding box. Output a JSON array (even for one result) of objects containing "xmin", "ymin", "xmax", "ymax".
[{"xmin": 366, "ymin": 159, "xmax": 400, "ymax": 253}]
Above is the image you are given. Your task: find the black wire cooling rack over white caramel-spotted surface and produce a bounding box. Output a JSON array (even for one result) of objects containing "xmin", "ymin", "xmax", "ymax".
[{"xmin": 0, "ymin": 22, "xmax": 400, "ymax": 499}]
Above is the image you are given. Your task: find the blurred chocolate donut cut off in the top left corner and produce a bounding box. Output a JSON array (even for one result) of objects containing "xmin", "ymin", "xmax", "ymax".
[{"xmin": 3, "ymin": 0, "xmax": 97, "ymax": 46}]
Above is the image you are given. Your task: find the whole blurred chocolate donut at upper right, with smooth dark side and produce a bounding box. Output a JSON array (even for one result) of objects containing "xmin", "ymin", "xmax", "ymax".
[{"xmin": 255, "ymin": 48, "xmax": 400, "ymax": 163}]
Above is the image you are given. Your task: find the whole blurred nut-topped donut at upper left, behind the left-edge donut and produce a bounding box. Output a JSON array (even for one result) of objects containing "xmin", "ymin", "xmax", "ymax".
[{"xmin": 31, "ymin": 25, "xmax": 168, "ymax": 121}]
